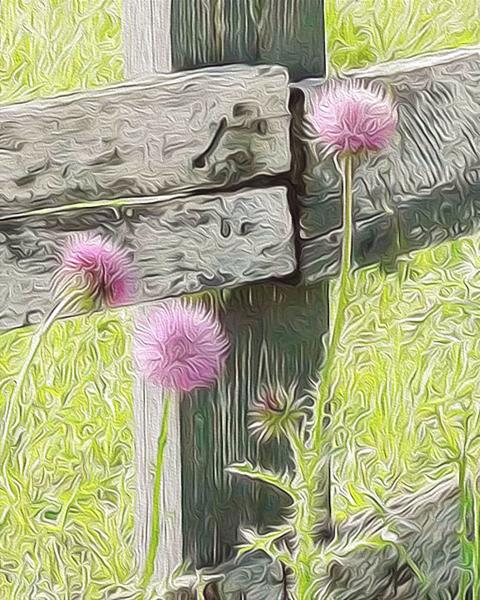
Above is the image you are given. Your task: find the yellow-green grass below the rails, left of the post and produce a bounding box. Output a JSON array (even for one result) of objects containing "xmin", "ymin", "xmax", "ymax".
[{"xmin": 0, "ymin": 312, "xmax": 134, "ymax": 600}]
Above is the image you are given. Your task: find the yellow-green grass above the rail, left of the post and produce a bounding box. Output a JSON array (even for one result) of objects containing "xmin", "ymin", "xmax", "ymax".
[{"xmin": 0, "ymin": 0, "xmax": 123, "ymax": 103}]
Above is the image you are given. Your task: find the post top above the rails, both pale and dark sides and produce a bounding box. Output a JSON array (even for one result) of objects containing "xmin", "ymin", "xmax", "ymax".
[{"xmin": 122, "ymin": 0, "xmax": 325, "ymax": 79}]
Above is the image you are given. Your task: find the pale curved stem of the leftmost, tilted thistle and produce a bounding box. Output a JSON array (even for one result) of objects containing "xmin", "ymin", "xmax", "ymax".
[{"xmin": 0, "ymin": 290, "xmax": 85, "ymax": 494}]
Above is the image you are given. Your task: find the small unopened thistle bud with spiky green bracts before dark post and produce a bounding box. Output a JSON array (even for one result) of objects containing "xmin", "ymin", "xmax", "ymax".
[{"xmin": 249, "ymin": 386, "xmax": 305, "ymax": 442}]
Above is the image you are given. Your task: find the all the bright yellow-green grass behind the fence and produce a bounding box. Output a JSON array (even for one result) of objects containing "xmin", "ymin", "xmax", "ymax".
[{"xmin": 0, "ymin": 0, "xmax": 480, "ymax": 600}]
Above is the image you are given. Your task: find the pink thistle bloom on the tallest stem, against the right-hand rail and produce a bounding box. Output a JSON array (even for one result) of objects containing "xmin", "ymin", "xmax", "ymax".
[{"xmin": 312, "ymin": 80, "xmax": 398, "ymax": 154}]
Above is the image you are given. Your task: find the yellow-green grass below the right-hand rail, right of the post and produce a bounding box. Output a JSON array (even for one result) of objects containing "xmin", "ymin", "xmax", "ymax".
[{"xmin": 335, "ymin": 234, "xmax": 480, "ymax": 516}]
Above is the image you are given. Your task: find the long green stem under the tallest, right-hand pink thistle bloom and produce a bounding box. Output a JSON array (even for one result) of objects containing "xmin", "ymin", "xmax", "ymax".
[{"xmin": 310, "ymin": 154, "xmax": 353, "ymax": 531}]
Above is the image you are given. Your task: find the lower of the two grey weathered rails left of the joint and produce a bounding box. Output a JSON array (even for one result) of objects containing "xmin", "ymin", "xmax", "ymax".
[{"xmin": 0, "ymin": 187, "xmax": 296, "ymax": 329}]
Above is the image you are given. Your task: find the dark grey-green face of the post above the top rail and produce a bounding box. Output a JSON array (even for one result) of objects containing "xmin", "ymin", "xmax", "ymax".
[{"xmin": 169, "ymin": 0, "xmax": 325, "ymax": 79}]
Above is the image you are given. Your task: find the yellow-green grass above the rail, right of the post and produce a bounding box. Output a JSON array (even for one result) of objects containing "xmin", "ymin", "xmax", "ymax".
[{"xmin": 325, "ymin": 0, "xmax": 480, "ymax": 71}]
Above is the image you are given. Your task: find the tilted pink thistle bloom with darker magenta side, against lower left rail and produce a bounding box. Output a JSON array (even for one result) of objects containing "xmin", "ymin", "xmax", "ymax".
[{"xmin": 60, "ymin": 234, "xmax": 134, "ymax": 306}]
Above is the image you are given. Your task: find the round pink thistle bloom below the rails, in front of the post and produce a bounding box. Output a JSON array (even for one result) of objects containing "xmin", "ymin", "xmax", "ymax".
[{"xmin": 135, "ymin": 300, "xmax": 228, "ymax": 392}]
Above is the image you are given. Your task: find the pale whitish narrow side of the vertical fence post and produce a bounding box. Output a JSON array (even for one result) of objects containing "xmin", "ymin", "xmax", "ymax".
[{"xmin": 123, "ymin": 8, "xmax": 183, "ymax": 581}]
